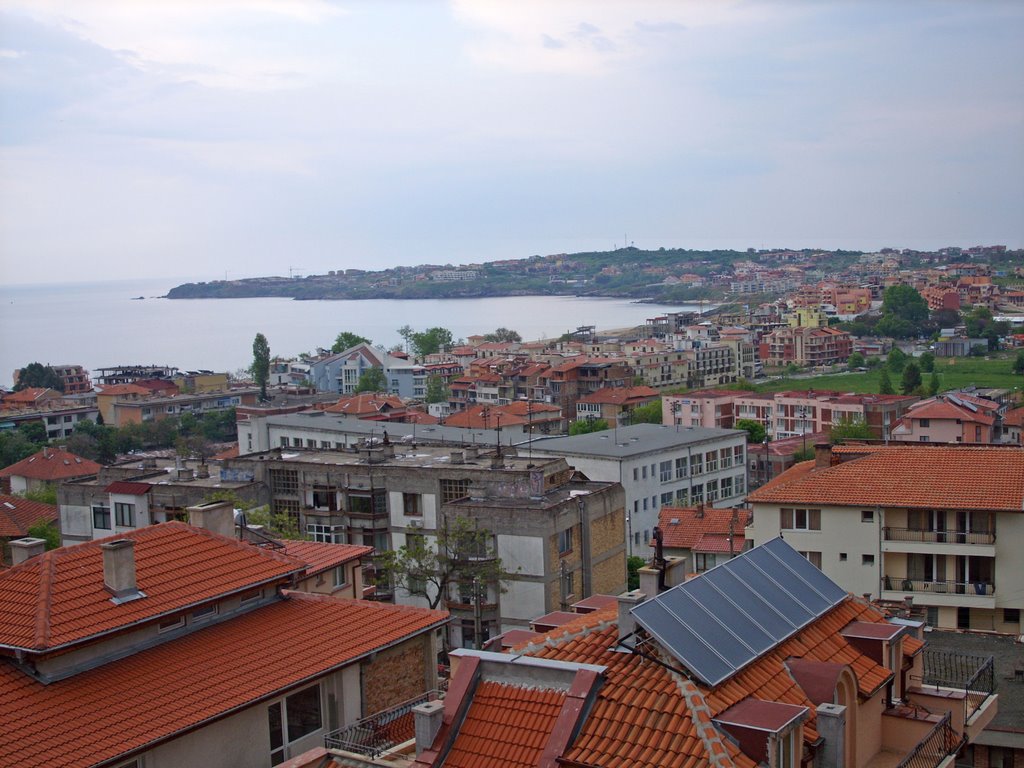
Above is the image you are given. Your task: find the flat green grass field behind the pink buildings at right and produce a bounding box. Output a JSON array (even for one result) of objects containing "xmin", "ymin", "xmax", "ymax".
[{"xmin": 757, "ymin": 353, "xmax": 1024, "ymax": 394}]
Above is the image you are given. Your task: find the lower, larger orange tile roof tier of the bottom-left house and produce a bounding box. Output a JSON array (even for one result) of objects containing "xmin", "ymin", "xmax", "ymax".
[{"xmin": 0, "ymin": 592, "xmax": 447, "ymax": 768}]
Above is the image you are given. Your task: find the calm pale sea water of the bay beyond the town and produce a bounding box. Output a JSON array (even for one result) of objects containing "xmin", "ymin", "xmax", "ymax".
[{"xmin": 0, "ymin": 281, "xmax": 704, "ymax": 385}]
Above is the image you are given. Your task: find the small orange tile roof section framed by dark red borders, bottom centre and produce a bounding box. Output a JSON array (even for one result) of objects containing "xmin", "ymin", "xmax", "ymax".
[{"xmin": 444, "ymin": 680, "xmax": 565, "ymax": 768}]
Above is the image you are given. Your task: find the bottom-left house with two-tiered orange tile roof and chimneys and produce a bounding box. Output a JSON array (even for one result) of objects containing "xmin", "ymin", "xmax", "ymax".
[{"xmin": 0, "ymin": 518, "xmax": 447, "ymax": 768}]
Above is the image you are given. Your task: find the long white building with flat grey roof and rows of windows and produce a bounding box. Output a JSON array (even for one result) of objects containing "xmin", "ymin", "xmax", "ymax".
[{"xmin": 520, "ymin": 424, "xmax": 746, "ymax": 555}]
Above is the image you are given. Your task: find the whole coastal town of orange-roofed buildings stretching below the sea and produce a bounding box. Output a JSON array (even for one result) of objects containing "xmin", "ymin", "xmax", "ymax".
[{"xmin": 0, "ymin": 246, "xmax": 1024, "ymax": 768}]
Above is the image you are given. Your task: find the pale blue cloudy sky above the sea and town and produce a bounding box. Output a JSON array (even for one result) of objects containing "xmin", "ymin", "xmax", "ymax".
[{"xmin": 0, "ymin": 0, "xmax": 1024, "ymax": 285}]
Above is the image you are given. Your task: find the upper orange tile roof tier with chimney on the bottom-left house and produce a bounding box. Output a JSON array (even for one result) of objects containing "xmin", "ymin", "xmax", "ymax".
[{"xmin": 0, "ymin": 522, "xmax": 305, "ymax": 651}]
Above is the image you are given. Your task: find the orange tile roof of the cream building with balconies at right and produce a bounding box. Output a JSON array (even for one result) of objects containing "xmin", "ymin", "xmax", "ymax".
[{"xmin": 746, "ymin": 443, "xmax": 1024, "ymax": 512}]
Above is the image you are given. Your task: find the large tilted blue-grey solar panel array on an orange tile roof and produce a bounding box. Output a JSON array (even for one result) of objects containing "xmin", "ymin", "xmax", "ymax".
[{"xmin": 631, "ymin": 538, "xmax": 847, "ymax": 686}]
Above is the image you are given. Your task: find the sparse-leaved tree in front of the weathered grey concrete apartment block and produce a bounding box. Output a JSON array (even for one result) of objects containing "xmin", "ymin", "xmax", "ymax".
[{"xmin": 377, "ymin": 516, "xmax": 512, "ymax": 608}]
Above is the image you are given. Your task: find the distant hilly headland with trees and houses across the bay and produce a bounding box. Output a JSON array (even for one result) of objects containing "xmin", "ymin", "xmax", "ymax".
[{"xmin": 167, "ymin": 246, "xmax": 1024, "ymax": 303}]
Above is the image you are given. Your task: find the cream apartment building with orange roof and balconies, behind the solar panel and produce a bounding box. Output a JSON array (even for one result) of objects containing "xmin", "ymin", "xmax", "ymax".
[{"xmin": 748, "ymin": 443, "xmax": 1024, "ymax": 634}]
